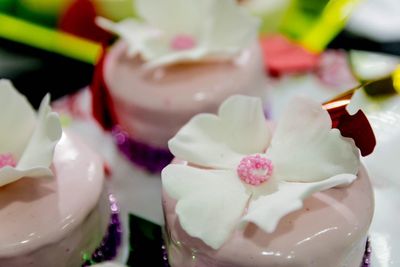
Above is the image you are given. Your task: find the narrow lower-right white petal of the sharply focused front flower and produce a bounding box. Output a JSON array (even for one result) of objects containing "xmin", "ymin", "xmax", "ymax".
[{"xmin": 242, "ymin": 174, "xmax": 357, "ymax": 233}]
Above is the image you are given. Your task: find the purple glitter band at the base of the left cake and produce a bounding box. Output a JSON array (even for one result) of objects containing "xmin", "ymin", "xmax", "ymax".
[{"xmin": 82, "ymin": 194, "xmax": 122, "ymax": 267}]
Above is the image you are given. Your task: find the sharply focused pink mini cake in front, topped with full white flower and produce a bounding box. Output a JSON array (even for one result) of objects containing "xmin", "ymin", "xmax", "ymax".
[{"xmin": 162, "ymin": 96, "xmax": 374, "ymax": 267}]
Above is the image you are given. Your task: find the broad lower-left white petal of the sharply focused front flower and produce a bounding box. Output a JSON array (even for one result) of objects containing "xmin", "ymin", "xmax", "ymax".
[{"xmin": 161, "ymin": 164, "xmax": 249, "ymax": 249}]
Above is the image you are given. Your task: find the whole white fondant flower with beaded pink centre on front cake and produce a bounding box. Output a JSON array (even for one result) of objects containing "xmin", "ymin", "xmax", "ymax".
[{"xmin": 162, "ymin": 96, "xmax": 359, "ymax": 249}]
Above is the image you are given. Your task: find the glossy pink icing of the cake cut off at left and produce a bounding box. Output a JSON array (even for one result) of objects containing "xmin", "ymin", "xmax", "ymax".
[{"xmin": 0, "ymin": 133, "xmax": 110, "ymax": 267}]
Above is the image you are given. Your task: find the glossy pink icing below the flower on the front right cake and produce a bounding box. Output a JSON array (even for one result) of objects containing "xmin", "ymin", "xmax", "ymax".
[{"xmin": 163, "ymin": 168, "xmax": 374, "ymax": 267}]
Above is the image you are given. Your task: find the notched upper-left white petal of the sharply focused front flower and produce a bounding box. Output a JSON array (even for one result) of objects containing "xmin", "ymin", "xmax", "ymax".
[{"xmin": 169, "ymin": 96, "xmax": 270, "ymax": 169}]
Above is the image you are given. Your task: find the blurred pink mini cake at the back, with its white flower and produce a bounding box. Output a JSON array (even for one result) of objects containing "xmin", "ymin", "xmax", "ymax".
[{"xmin": 92, "ymin": 0, "xmax": 266, "ymax": 172}]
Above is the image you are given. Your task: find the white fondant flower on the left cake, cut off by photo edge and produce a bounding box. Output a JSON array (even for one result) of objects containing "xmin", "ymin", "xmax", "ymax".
[{"xmin": 0, "ymin": 80, "xmax": 62, "ymax": 186}]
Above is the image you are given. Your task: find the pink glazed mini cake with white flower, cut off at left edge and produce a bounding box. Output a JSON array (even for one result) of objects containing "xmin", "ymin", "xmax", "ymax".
[{"xmin": 0, "ymin": 80, "xmax": 120, "ymax": 267}]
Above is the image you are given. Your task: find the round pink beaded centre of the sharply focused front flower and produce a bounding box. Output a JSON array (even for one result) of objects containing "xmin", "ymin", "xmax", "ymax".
[{"xmin": 237, "ymin": 155, "xmax": 273, "ymax": 186}]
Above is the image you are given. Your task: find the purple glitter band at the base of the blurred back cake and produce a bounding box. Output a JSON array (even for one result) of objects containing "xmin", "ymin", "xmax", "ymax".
[{"xmin": 111, "ymin": 126, "xmax": 174, "ymax": 173}]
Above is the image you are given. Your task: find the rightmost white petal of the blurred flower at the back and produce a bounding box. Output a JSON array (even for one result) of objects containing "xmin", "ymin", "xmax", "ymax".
[{"xmin": 209, "ymin": 0, "xmax": 260, "ymax": 55}]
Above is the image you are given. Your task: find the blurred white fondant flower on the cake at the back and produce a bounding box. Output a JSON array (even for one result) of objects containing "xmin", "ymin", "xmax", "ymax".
[{"xmin": 97, "ymin": 0, "xmax": 258, "ymax": 67}]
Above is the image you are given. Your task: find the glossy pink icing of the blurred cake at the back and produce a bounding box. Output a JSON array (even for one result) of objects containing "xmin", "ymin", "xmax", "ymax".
[{"xmin": 104, "ymin": 41, "xmax": 267, "ymax": 148}]
